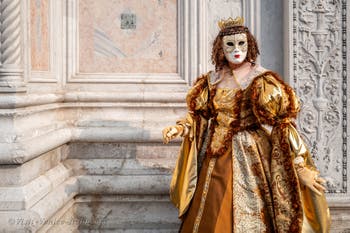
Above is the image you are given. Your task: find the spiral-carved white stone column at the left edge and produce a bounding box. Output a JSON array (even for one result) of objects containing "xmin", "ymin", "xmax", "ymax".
[{"xmin": 0, "ymin": 0, "xmax": 24, "ymax": 92}]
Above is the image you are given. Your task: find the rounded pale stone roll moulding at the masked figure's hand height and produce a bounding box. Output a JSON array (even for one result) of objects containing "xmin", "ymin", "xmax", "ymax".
[{"xmin": 0, "ymin": 122, "xmax": 183, "ymax": 164}]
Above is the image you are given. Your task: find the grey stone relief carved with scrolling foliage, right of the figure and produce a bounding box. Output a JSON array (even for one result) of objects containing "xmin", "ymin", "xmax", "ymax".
[{"xmin": 290, "ymin": 0, "xmax": 347, "ymax": 193}]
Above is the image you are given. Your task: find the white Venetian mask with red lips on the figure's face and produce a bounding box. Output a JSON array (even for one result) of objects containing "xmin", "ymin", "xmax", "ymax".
[{"xmin": 222, "ymin": 33, "xmax": 248, "ymax": 64}]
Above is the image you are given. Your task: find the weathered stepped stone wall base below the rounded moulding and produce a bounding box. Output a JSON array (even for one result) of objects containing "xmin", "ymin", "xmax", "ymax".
[{"xmin": 0, "ymin": 142, "xmax": 350, "ymax": 233}]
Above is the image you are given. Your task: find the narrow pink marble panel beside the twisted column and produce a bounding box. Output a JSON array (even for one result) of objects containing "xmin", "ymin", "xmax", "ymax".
[{"xmin": 30, "ymin": 0, "xmax": 50, "ymax": 71}]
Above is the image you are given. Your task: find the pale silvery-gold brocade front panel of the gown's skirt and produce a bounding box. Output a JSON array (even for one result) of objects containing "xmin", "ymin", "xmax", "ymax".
[{"xmin": 232, "ymin": 131, "xmax": 273, "ymax": 233}]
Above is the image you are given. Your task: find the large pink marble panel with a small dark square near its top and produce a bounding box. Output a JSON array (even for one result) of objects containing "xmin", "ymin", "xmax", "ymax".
[{"xmin": 79, "ymin": 0, "xmax": 177, "ymax": 73}]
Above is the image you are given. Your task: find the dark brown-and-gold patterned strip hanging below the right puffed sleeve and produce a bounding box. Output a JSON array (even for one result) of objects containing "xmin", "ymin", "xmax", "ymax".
[{"xmin": 271, "ymin": 123, "xmax": 303, "ymax": 233}]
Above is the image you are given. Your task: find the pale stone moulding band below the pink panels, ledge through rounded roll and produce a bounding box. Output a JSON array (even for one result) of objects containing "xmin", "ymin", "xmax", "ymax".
[{"xmin": 0, "ymin": 98, "xmax": 185, "ymax": 164}]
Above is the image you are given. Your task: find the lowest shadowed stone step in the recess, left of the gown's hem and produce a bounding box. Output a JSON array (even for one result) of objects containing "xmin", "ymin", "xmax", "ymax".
[{"xmin": 76, "ymin": 194, "xmax": 180, "ymax": 232}]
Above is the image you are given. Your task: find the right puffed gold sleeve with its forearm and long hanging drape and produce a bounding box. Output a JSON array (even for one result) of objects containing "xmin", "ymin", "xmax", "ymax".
[{"xmin": 251, "ymin": 72, "xmax": 329, "ymax": 232}]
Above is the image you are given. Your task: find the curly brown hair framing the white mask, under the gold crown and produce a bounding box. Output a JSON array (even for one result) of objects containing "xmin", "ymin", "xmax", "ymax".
[{"xmin": 211, "ymin": 26, "xmax": 260, "ymax": 71}]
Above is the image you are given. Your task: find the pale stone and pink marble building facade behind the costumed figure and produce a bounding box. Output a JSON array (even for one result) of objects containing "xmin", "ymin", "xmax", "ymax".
[{"xmin": 0, "ymin": 0, "xmax": 350, "ymax": 233}]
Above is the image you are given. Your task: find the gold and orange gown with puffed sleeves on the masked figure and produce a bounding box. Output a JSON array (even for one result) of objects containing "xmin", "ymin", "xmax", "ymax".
[{"xmin": 170, "ymin": 67, "xmax": 330, "ymax": 233}]
